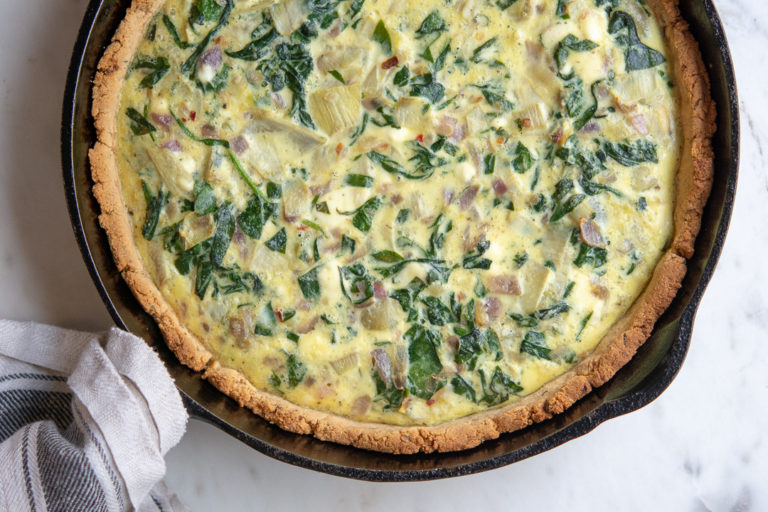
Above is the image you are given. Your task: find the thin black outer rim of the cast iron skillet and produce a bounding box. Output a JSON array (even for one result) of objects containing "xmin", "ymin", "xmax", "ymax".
[{"xmin": 61, "ymin": 0, "xmax": 739, "ymax": 481}]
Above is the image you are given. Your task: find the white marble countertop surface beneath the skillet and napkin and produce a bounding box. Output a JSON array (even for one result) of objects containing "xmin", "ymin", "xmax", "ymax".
[{"xmin": 0, "ymin": 0, "xmax": 768, "ymax": 512}]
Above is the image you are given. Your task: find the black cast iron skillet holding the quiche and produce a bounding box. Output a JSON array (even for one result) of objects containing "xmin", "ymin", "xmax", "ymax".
[{"xmin": 61, "ymin": 0, "xmax": 739, "ymax": 481}]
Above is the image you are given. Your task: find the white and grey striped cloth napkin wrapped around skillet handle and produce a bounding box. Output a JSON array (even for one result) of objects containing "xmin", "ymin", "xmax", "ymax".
[{"xmin": 0, "ymin": 320, "xmax": 188, "ymax": 512}]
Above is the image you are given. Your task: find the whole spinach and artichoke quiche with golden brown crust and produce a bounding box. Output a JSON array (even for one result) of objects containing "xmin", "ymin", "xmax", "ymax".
[{"xmin": 90, "ymin": 0, "xmax": 714, "ymax": 453}]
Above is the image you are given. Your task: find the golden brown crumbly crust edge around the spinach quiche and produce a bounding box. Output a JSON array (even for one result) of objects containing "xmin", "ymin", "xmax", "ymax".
[{"xmin": 90, "ymin": 0, "xmax": 715, "ymax": 453}]
